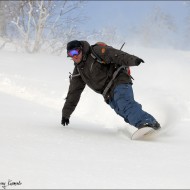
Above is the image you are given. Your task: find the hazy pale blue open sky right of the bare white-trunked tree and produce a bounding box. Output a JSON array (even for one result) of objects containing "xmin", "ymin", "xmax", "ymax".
[{"xmin": 83, "ymin": 1, "xmax": 187, "ymax": 30}]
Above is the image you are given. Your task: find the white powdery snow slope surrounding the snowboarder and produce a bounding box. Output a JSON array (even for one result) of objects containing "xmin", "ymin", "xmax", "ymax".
[{"xmin": 0, "ymin": 48, "xmax": 190, "ymax": 189}]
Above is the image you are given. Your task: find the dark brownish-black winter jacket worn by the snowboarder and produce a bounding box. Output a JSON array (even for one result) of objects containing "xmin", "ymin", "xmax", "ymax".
[{"xmin": 62, "ymin": 41, "xmax": 138, "ymax": 118}]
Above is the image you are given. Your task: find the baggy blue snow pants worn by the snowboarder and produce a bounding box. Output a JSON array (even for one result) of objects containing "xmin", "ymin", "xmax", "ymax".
[{"xmin": 109, "ymin": 84, "xmax": 156, "ymax": 128}]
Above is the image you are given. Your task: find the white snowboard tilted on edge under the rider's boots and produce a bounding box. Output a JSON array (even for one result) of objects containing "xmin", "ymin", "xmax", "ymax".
[{"xmin": 131, "ymin": 127, "xmax": 158, "ymax": 140}]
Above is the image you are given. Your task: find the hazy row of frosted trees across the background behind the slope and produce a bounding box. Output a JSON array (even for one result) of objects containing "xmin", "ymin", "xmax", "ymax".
[{"xmin": 0, "ymin": 0, "xmax": 190, "ymax": 54}]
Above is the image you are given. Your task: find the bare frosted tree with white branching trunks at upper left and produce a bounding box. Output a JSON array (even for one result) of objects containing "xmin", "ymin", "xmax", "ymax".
[{"xmin": 2, "ymin": 0, "xmax": 84, "ymax": 53}]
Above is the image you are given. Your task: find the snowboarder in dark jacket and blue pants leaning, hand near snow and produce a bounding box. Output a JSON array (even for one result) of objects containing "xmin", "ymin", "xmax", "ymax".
[{"xmin": 61, "ymin": 40, "xmax": 160, "ymax": 130}]
